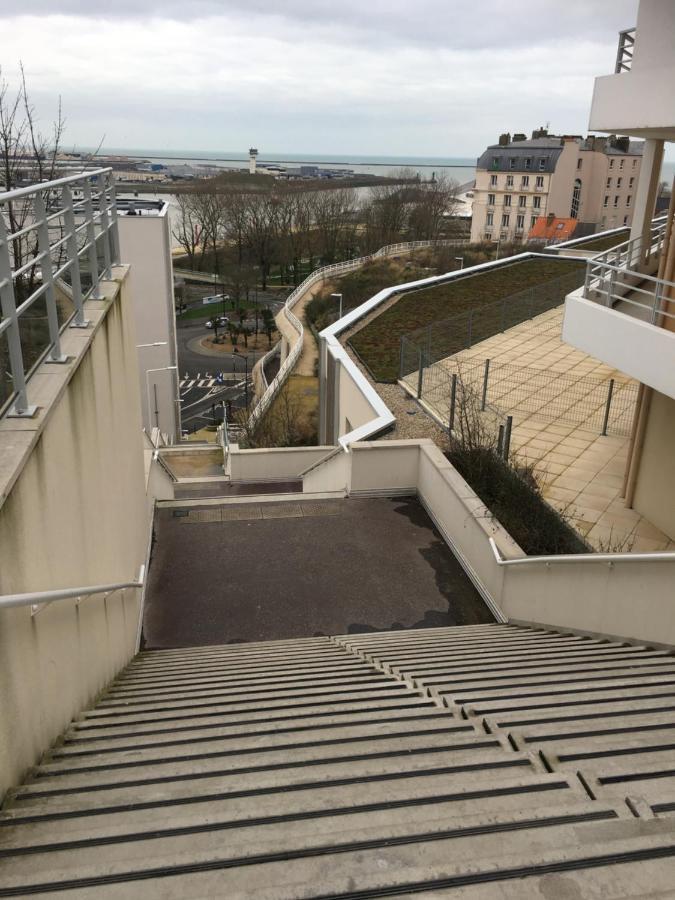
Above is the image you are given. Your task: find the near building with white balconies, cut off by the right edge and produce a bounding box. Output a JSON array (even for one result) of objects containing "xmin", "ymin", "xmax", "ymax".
[{"xmin": 563, "ymin": 0, "xmax": 675, "ymax": 535}]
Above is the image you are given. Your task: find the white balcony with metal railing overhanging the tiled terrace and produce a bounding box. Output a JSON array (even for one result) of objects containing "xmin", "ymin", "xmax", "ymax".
[{"xmin": 563, "ymin": 222, "xmax": 675, "ymax": 398}]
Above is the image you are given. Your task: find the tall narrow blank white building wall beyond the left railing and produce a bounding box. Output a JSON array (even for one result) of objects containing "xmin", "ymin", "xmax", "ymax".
[{"xmin": 118, "ymin": 205, "xmax": 181, "ymax": 441}]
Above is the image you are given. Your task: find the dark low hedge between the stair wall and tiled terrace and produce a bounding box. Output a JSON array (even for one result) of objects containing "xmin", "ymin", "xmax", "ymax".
[{"xmin": 445, "ymin": 447, "xmax": 590, "ymax": 556}]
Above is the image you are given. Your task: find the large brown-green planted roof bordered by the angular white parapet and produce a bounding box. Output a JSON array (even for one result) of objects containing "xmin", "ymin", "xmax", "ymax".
[{"xmin": 350, "ymin": 258, "xmax": 585, "ymax": 382}]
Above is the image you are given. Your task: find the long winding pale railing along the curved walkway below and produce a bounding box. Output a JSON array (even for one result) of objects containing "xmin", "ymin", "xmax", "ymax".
[{"xmin": 248, "ymin": 240, "xmax": 468, "ymax": 430}]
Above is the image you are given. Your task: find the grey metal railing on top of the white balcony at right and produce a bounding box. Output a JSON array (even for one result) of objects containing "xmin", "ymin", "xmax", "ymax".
[{"xmin": 583, "ymin": 218, "xmax": 675, "ymax": 330}]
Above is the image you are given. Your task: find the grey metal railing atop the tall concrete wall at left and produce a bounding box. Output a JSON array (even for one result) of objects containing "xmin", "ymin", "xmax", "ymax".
[{"xmin": 0, "ymin": 168, "xmax": 119, "ymax": 416}]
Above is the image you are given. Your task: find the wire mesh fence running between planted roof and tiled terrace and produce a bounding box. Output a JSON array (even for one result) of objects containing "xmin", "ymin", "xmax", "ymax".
[{"xmin": 399, "ymin": 271, "xmax": 584, "ymax": 378}]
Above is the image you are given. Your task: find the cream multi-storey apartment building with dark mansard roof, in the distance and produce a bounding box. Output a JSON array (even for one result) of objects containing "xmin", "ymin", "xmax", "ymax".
[{"xmin": 471, "ymin": 129, "xmax": 642, "ymax": 243}]
